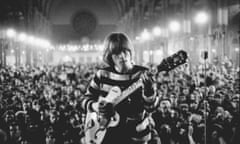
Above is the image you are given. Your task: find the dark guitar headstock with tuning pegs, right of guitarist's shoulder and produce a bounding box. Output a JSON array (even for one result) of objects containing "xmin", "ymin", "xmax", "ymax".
[{"xmin": 157, "ymin": 50, "xmax": 188, "ymax": 72}]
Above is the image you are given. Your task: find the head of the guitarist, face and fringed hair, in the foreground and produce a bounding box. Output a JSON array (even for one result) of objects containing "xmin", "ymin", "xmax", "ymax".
[{"xmin": 103, "ymin": 33, "xmax": 133, "ymax": 71}]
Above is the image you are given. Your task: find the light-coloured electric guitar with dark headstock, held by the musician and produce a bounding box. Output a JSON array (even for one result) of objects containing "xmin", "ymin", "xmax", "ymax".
[{"xmin": 84, "ymin": 50, "xmax": 188, "ymax": 144}]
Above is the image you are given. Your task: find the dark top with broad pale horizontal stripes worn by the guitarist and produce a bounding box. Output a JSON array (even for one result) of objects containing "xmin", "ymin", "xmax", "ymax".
[{"xmin": 81, "ymin": 65, "xmax": 157, "ymax": 144}]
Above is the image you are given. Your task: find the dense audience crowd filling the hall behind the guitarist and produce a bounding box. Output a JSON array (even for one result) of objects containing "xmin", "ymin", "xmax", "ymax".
[{"xmin": 0, "ymin": 58, "xmax": 240, "ymax": 144}]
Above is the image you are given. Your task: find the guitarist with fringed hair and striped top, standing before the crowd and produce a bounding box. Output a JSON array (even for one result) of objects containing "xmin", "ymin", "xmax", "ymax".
[{"xmin": 80, "ymin": 33, "xmax": 157, "ymax": 144}]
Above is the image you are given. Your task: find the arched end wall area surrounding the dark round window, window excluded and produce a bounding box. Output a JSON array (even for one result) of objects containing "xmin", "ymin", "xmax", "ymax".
[{"xmin": 46, "ymin": 0, "xmax": 125, "ymax": 42}]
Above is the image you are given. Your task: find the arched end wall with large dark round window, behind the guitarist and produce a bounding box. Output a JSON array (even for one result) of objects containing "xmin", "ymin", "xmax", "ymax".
[{"xmin": 48, "ymin": 0, "xmax": 137, "ymax": 42}]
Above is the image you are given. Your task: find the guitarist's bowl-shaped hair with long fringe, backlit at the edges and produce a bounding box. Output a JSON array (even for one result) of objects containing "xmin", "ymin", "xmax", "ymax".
[{"xmin": 103, "ymin": 32, "xmax": 133, "ymax": 66}]
